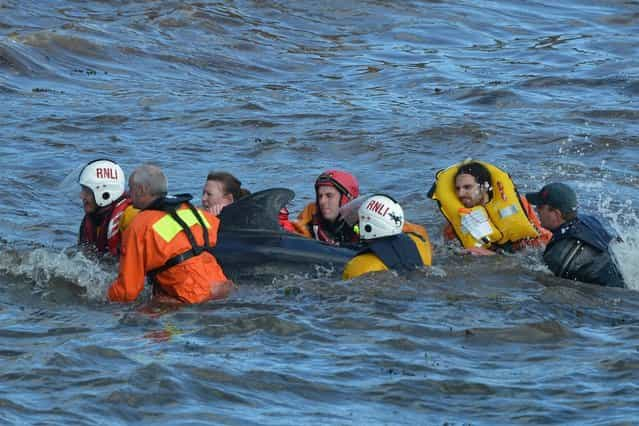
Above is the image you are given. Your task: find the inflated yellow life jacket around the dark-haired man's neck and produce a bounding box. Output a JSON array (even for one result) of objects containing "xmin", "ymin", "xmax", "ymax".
[{"xmin": 429, "ymin": 160, "xmax": 539, "ymax": 248}]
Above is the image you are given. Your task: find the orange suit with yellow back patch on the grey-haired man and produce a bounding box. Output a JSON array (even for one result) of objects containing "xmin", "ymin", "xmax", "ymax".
[{"xmin": 108, "ymin": 204, "xmax": 227, "ymax": 303}]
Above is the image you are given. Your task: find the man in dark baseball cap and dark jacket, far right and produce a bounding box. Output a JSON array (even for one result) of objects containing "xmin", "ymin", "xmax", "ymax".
[{"xmin": 526, "ymin": 183, "xmax": 626, "ymax": 287}]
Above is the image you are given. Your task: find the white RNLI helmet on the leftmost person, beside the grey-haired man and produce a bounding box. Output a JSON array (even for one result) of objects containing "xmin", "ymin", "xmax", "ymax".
[{"xmin": 78, "ymin": 160, "xmax": 126, "ymax": 207}]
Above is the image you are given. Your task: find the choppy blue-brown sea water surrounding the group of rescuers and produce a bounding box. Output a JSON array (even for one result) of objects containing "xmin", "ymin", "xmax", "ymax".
[{"xmin": 0, "ymin": 0, "xmax": 639, "ymax": 425}]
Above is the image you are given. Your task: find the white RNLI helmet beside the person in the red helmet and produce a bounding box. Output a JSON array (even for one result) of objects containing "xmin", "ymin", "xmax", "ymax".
[{"xmin": 357, "ymin": 194, "xmax": 404, "ymax": 240}]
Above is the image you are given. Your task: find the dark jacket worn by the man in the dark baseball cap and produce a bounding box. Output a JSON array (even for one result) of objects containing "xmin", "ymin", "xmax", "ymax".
[{"xmin": 544, "ymin": 215, "xmax": 625, "ymax": 287}]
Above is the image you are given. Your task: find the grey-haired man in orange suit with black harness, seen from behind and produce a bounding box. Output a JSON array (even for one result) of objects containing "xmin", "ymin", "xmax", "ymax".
[{"xmin": 108, "ymin": 164, "xmax": 233, "ymax": 303}]
